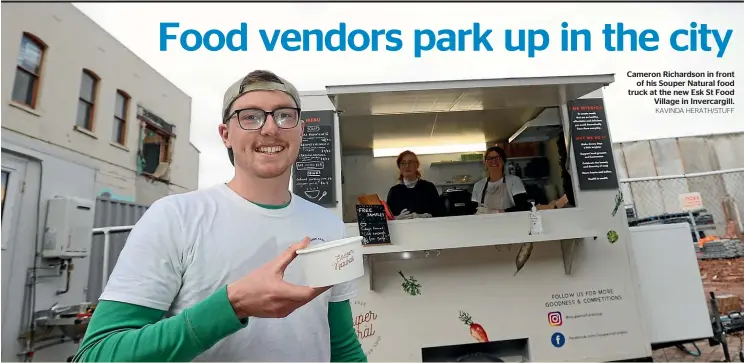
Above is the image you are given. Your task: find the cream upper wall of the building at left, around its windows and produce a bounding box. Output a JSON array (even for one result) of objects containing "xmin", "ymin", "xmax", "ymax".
[{"xmin": 1, "ymin": 3, "xmax": 199, "ymax": 204}]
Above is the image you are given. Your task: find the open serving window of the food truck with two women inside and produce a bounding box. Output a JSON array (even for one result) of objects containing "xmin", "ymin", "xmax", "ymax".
[{"xmin": 328, "ymin": 76, "xmax": 617, "ymax": 222}]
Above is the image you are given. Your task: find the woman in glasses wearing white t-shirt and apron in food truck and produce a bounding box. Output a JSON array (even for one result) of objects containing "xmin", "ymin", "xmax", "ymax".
[{"xmin": 473, "ymin": 146, "xmax": 532, "ymax": 214}]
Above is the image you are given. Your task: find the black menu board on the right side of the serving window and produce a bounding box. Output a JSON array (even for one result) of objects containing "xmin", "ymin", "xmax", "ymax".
[{"xmin": 567, "ymin": 98, "xmax": 618, "ymax": 190}]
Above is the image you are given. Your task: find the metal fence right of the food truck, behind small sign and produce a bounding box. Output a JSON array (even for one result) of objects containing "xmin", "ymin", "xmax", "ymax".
[{"xmin": 620, "ymin": 168, "xmax": 744, "ymax": 236}]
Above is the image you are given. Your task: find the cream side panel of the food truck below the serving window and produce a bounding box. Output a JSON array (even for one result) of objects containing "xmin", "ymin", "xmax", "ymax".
[{"xmin": 347, "ymin": 209, "xmax": 650, "ymax": 362}]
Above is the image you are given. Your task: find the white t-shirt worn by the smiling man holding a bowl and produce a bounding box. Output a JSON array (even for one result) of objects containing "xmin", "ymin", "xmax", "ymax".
[{"xmin": 100, "ymin": 184, "xmax": 357, "ymax": 362}]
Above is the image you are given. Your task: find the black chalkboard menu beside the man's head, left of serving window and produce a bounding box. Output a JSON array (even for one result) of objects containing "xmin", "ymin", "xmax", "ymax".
[{"xmin": 292, "ymin": 111, "xmax": 337, "ymax": 207}]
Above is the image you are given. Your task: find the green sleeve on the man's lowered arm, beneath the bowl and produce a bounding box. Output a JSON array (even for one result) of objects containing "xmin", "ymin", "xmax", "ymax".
[{"xmin": 328, "ymin": 300, "xmax": 367, "ymax": 362}]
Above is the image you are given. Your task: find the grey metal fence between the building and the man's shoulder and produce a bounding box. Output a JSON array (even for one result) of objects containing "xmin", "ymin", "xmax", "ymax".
[{"xmin": 88, "ymin": 197, "xmax": 148, "ymax": 302}]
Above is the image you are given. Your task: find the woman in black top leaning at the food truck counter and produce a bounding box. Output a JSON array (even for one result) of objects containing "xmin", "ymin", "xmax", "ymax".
[{"xmin": 387, "ymin": 150, "xmax": 444, "ymax": 219}]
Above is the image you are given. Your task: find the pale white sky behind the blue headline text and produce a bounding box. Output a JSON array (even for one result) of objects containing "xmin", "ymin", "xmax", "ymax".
[{"xmin": 75, "ymin": 3, "xmax": 744, "ymax": 188}]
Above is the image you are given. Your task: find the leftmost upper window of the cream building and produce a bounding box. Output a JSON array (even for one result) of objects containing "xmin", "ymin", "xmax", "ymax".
[{"xmin": 12, "ymin": 33, "xmax": 46, "ymax": 108}]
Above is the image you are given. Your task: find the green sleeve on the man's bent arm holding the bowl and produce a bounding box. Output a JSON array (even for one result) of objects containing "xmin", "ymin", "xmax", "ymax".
[{"xmin": 73, "ymin": 286, "xmax": 248, "ymax": 362}]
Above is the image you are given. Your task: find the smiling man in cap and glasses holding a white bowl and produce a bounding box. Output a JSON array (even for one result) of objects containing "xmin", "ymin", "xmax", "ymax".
[{"xmin": 74, "ymin": 71, "xmax": 367, "ymax": 362}]
